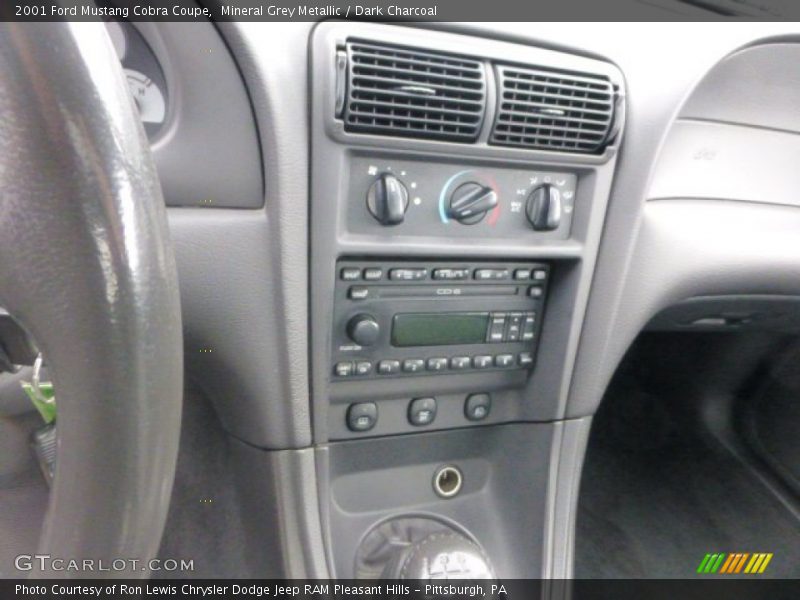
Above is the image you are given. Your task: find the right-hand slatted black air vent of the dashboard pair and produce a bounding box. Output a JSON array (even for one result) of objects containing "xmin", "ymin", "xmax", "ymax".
[{"xmin": 490, "ymin": 65, "xmax": 615, "ymax": 153}]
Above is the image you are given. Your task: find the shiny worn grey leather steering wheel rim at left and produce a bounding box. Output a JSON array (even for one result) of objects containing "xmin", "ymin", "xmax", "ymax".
[{"xmin": 0, "ymin": 22, "xmax": 183, "ymax": 577}]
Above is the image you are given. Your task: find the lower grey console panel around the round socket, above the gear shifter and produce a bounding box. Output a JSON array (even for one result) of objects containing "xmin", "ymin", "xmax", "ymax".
[{"xmin": 319, "ymin": 424, "xmax": 555, "ymax": 578}]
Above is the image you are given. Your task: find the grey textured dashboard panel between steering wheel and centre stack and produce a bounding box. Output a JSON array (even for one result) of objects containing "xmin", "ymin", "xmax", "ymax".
[{"xmin": 169, "ymin": 23, "xmax": 311, "ymax": 449}]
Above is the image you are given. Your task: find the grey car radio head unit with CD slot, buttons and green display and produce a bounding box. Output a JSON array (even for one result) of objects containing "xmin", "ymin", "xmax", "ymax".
[{"xmin": 331, "ymin": 260, "xmax": 549, "ymax": 381}]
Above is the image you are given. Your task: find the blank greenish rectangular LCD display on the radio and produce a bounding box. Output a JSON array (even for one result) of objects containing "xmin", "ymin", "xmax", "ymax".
[{"xmin": 392, "ymin": 312, "xmax": 489, "ymax": 347}]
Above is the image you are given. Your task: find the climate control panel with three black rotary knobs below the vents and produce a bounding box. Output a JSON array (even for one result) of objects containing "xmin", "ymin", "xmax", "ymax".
[{"xmin": 347, "ymin": 157, "xmax": 578, "ymax": 239}]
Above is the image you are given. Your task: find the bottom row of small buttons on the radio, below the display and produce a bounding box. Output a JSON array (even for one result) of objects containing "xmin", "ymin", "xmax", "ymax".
[{"xmin": 334, "ymin": 352, "xmax": 533, "ymax": 377}]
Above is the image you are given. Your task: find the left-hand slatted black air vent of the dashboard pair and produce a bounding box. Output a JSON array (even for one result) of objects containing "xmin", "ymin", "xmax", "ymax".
[{"xmin": 343, "ymin": 42, "xmax": 486, "ymax": 142}]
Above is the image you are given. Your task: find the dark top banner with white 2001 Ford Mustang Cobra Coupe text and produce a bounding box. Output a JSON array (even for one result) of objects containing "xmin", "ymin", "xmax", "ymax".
[{"xmin": 0, "ymin": 0, "xmax": 800, "ymax": 22}]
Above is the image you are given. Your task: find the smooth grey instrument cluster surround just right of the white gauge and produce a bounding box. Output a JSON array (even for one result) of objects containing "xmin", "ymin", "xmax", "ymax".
[{"xmin": 135, "ymin": 21, "xmax": 267, "ymax": 208}]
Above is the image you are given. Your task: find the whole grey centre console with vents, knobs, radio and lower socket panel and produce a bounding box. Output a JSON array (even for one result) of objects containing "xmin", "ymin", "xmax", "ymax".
[{"xmin": 309, "ymin": 22, "xmax": 624, "ymax": 577}]
